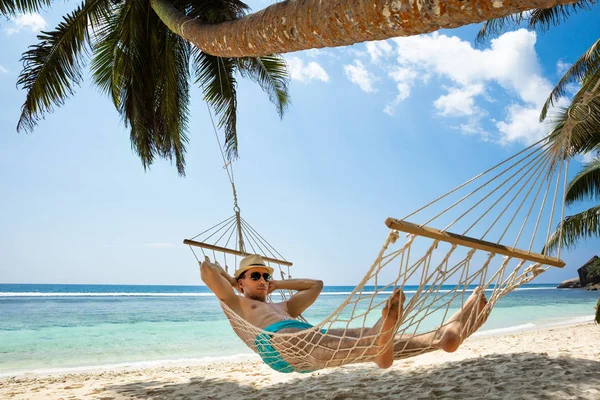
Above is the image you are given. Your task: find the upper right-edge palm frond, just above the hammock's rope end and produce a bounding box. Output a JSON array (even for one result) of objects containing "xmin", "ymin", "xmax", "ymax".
[{"xmin": 540, "ymin": 39, "xmax": 600, "ymax": 121}]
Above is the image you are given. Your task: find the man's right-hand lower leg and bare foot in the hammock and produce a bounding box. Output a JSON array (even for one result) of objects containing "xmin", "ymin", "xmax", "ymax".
[{"xmin": 394, "ymin": 287, "xmax": 487, "ymax": 356}]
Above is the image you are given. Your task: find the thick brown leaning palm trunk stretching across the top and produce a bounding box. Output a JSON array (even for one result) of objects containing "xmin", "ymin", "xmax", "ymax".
[{"xmin": 150, "ymin": 0, "xmax": 577, "ymax": 57}]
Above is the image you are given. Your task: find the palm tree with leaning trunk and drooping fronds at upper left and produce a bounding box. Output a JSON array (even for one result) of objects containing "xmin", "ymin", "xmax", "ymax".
[{"xmin": 0, "ymin": 0, "xmax": 595, "ymax": 174}]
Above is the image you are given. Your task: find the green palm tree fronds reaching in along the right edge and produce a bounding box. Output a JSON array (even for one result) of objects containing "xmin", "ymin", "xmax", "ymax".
[{"xmin": 477, "ymin": 0, "xmax": 600, "ymax": 253}]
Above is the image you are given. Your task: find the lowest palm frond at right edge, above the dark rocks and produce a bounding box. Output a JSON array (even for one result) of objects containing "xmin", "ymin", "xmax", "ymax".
[{"xmin": 542, "ymin": 206, "xmax": 600, "ymax": 254}]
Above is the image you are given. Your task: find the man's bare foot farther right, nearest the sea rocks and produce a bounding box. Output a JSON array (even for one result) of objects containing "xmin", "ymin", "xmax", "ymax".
[{"xmin": 438, "ymin": 287, "xmax": 487, "ymax": 353}]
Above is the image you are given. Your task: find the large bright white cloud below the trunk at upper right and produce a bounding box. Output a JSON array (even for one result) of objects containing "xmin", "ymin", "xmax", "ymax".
[{"xmin": 376, "ymin": 29, "xmax": 564, "ymax": 143}]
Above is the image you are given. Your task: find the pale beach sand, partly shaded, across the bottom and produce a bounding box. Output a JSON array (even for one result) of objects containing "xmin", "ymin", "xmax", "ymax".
[{"xmin": 0, "ymin": 323, "xmax": 600, "ymax": 400}]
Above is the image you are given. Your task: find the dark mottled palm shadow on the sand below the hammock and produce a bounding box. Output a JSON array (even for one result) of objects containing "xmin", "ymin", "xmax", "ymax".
[{"xmin": 103, "ymin": 353, "xmax": 600, "ymax": 400}]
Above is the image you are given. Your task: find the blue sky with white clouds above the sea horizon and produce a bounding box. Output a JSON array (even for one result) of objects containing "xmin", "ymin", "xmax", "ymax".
[{"xmin": 0, "ymin": 2, "xmax": 600, "ymax": 285}]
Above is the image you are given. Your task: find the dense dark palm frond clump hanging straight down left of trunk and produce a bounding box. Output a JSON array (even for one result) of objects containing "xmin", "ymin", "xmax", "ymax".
[{"xmin": 102, "ymin": 0, "xmax": 190, "ymax": 175}]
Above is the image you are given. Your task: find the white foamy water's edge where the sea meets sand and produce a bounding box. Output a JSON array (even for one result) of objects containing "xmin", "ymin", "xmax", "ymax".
[{"xmin": 0, "ymin": 315, "xmax": 594, "ymax": 382}]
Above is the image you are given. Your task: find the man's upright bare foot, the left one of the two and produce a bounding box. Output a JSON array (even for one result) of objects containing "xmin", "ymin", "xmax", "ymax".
[{"xmin": 375, "ymin": 289, "xmax": 406, "ymax": 368}]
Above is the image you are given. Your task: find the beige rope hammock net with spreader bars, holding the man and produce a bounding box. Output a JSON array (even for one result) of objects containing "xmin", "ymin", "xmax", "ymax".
[{"xmin": 184, "ymin": 104, "xmax": 584, "ymax": 372}]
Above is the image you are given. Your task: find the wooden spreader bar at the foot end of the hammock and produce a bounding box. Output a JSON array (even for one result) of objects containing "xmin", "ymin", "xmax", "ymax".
[{"xmin": 385, "ymin": 218, "xmax": 565, "ymax": 268}]
